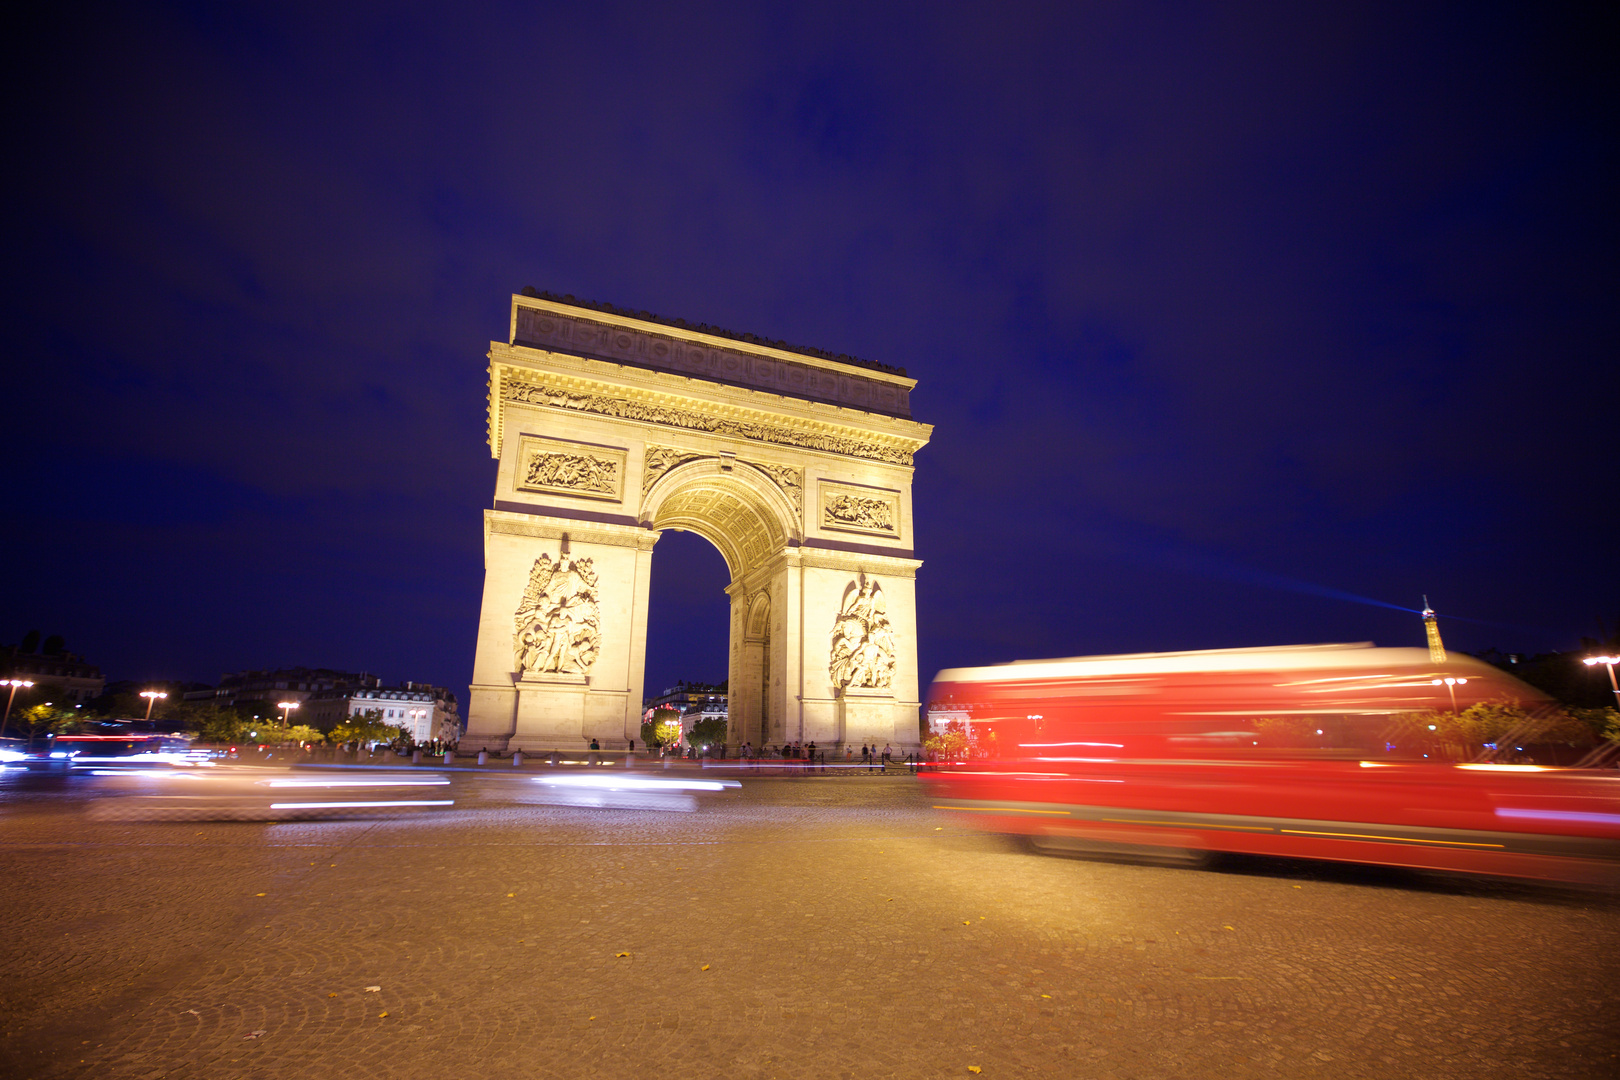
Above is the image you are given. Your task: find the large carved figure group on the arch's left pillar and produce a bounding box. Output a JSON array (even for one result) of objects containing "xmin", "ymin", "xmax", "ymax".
[{"xmin": 512, "ymin": 554, "xmax": 603, "ymax": 678}]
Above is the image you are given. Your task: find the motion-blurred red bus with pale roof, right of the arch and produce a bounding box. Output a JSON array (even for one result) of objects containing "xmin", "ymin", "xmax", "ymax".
[{"xmin": 927, "ymin": 644, "xmax": 1620, "ymax": 886}]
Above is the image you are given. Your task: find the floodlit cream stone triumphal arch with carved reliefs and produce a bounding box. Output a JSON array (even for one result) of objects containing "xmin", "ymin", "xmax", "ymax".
[{"xmin": 462, "ymin": 295, "xmax": 932, "ymax": 750}]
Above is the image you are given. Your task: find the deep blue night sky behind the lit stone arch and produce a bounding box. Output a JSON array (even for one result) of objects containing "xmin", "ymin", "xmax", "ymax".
[{"xmin": 0, "ymin": 3, "xmax": 1620, "ymax": 702}]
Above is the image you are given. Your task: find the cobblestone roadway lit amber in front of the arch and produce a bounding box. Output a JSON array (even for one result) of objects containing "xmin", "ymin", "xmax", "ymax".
[{"xmin": 0, "ymin": 772, "xmax": 1620, "ymax": 1080}]
